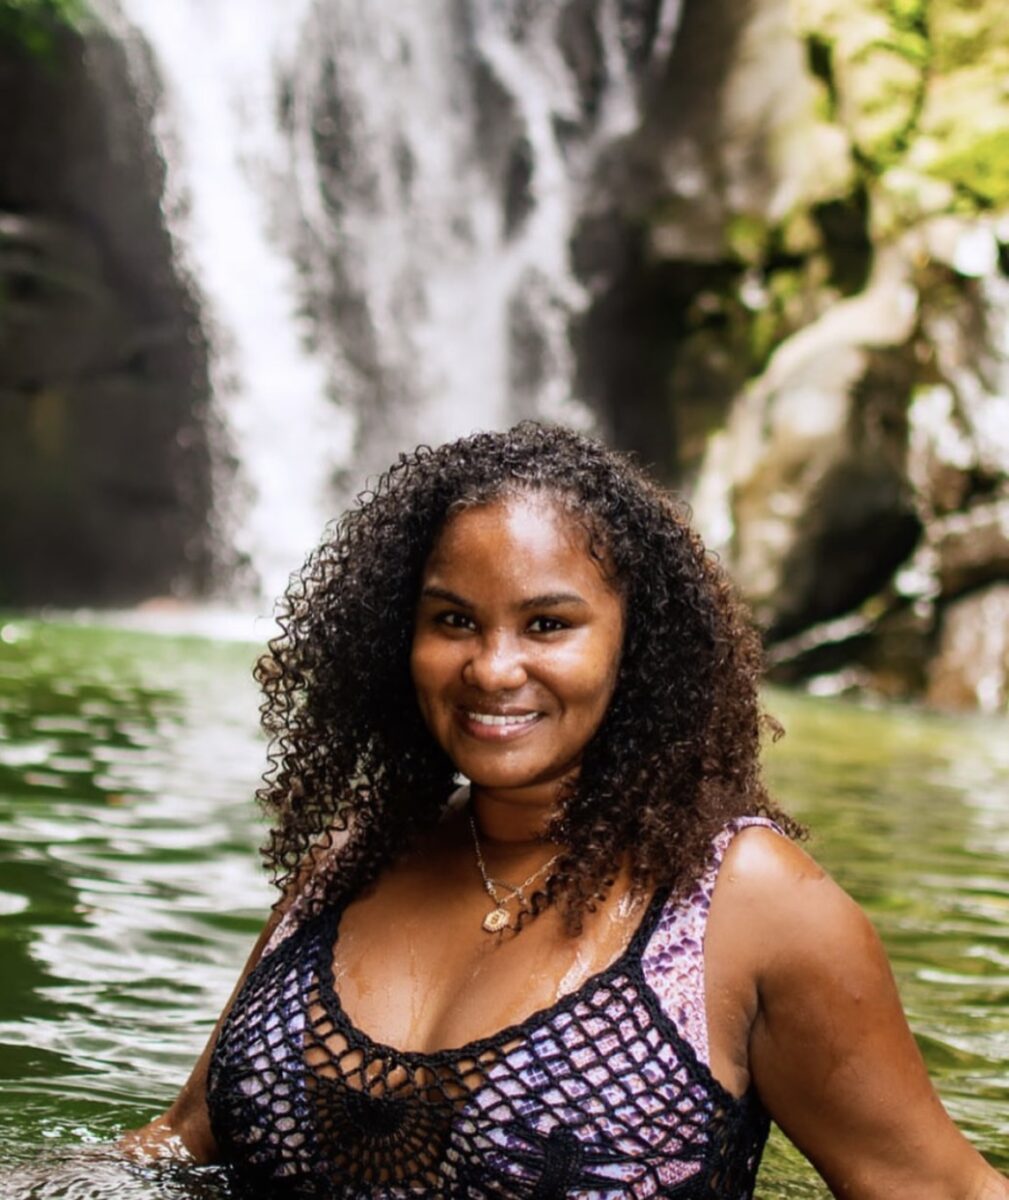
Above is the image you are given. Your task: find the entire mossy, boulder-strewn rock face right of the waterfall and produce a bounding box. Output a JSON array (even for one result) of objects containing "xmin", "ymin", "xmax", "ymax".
[{"xmin": 628, "ymin": 0, "xmax": 1009, "ymax": 709}]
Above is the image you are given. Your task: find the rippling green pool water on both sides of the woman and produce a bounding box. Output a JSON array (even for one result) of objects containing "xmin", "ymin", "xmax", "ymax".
[{"xmin": 0, "ymin": 618, "xmax": 1009, "ymax": 1200}]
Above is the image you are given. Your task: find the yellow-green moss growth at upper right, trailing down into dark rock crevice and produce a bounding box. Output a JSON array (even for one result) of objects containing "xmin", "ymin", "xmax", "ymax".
[{"xmin": 707, "ymin": 0, "xmax": 1009, "ymax": 400}]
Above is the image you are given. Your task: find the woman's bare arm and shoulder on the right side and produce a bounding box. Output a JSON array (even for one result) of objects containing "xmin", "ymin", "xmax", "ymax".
[{"xmin": 713, "ymin": 829, "xmax": 1009, "ymax": 1200}]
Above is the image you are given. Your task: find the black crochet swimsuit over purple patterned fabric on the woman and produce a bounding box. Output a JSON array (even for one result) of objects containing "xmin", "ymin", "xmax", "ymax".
[{"xmin": 208, "ymin": 817, "xmax": 769, "ymax": 1200}]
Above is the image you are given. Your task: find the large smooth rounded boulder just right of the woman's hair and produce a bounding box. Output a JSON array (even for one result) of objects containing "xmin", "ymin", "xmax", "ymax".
[{"xmin": 695, "ymin": 246, "xmax": 919, "ymax": 638}]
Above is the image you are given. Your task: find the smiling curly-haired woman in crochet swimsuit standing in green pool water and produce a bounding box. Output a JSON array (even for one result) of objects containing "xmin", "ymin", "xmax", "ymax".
[{"xmin": 121, "ymin": 424, "xmax": 1009, "ymax": 1200}]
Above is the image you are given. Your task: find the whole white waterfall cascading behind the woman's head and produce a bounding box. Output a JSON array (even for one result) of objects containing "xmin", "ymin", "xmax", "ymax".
[{"xmin": 98, "ymin": 0, "xmax": 679, "ymax": 595}]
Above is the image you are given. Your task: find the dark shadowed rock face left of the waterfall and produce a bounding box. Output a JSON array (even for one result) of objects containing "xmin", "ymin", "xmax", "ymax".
[{"xmin": 0, "ymin": 31, "xmax": 210, "ymax": 605}]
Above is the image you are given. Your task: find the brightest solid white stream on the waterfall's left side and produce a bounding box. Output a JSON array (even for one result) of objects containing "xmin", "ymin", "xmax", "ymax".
[{"xmin": 95, "ymin": 0, "xmax": 353, "ymax": 596}]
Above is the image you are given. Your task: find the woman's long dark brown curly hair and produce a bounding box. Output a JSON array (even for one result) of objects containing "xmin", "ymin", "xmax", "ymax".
[{"xmin": 256, "ymin": 421, "xmax": 800, "ymax": 932}]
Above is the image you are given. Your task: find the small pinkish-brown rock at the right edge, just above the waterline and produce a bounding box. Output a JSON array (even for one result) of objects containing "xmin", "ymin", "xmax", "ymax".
[{"xmin": 926, "ymin": 583, "xmax": 1009, "ymax": 713}]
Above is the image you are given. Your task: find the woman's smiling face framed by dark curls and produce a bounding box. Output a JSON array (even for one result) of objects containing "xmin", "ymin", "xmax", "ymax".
[{"xmin": 410, "ymin": 494, "xmax": 624, "ymax": 803}]
